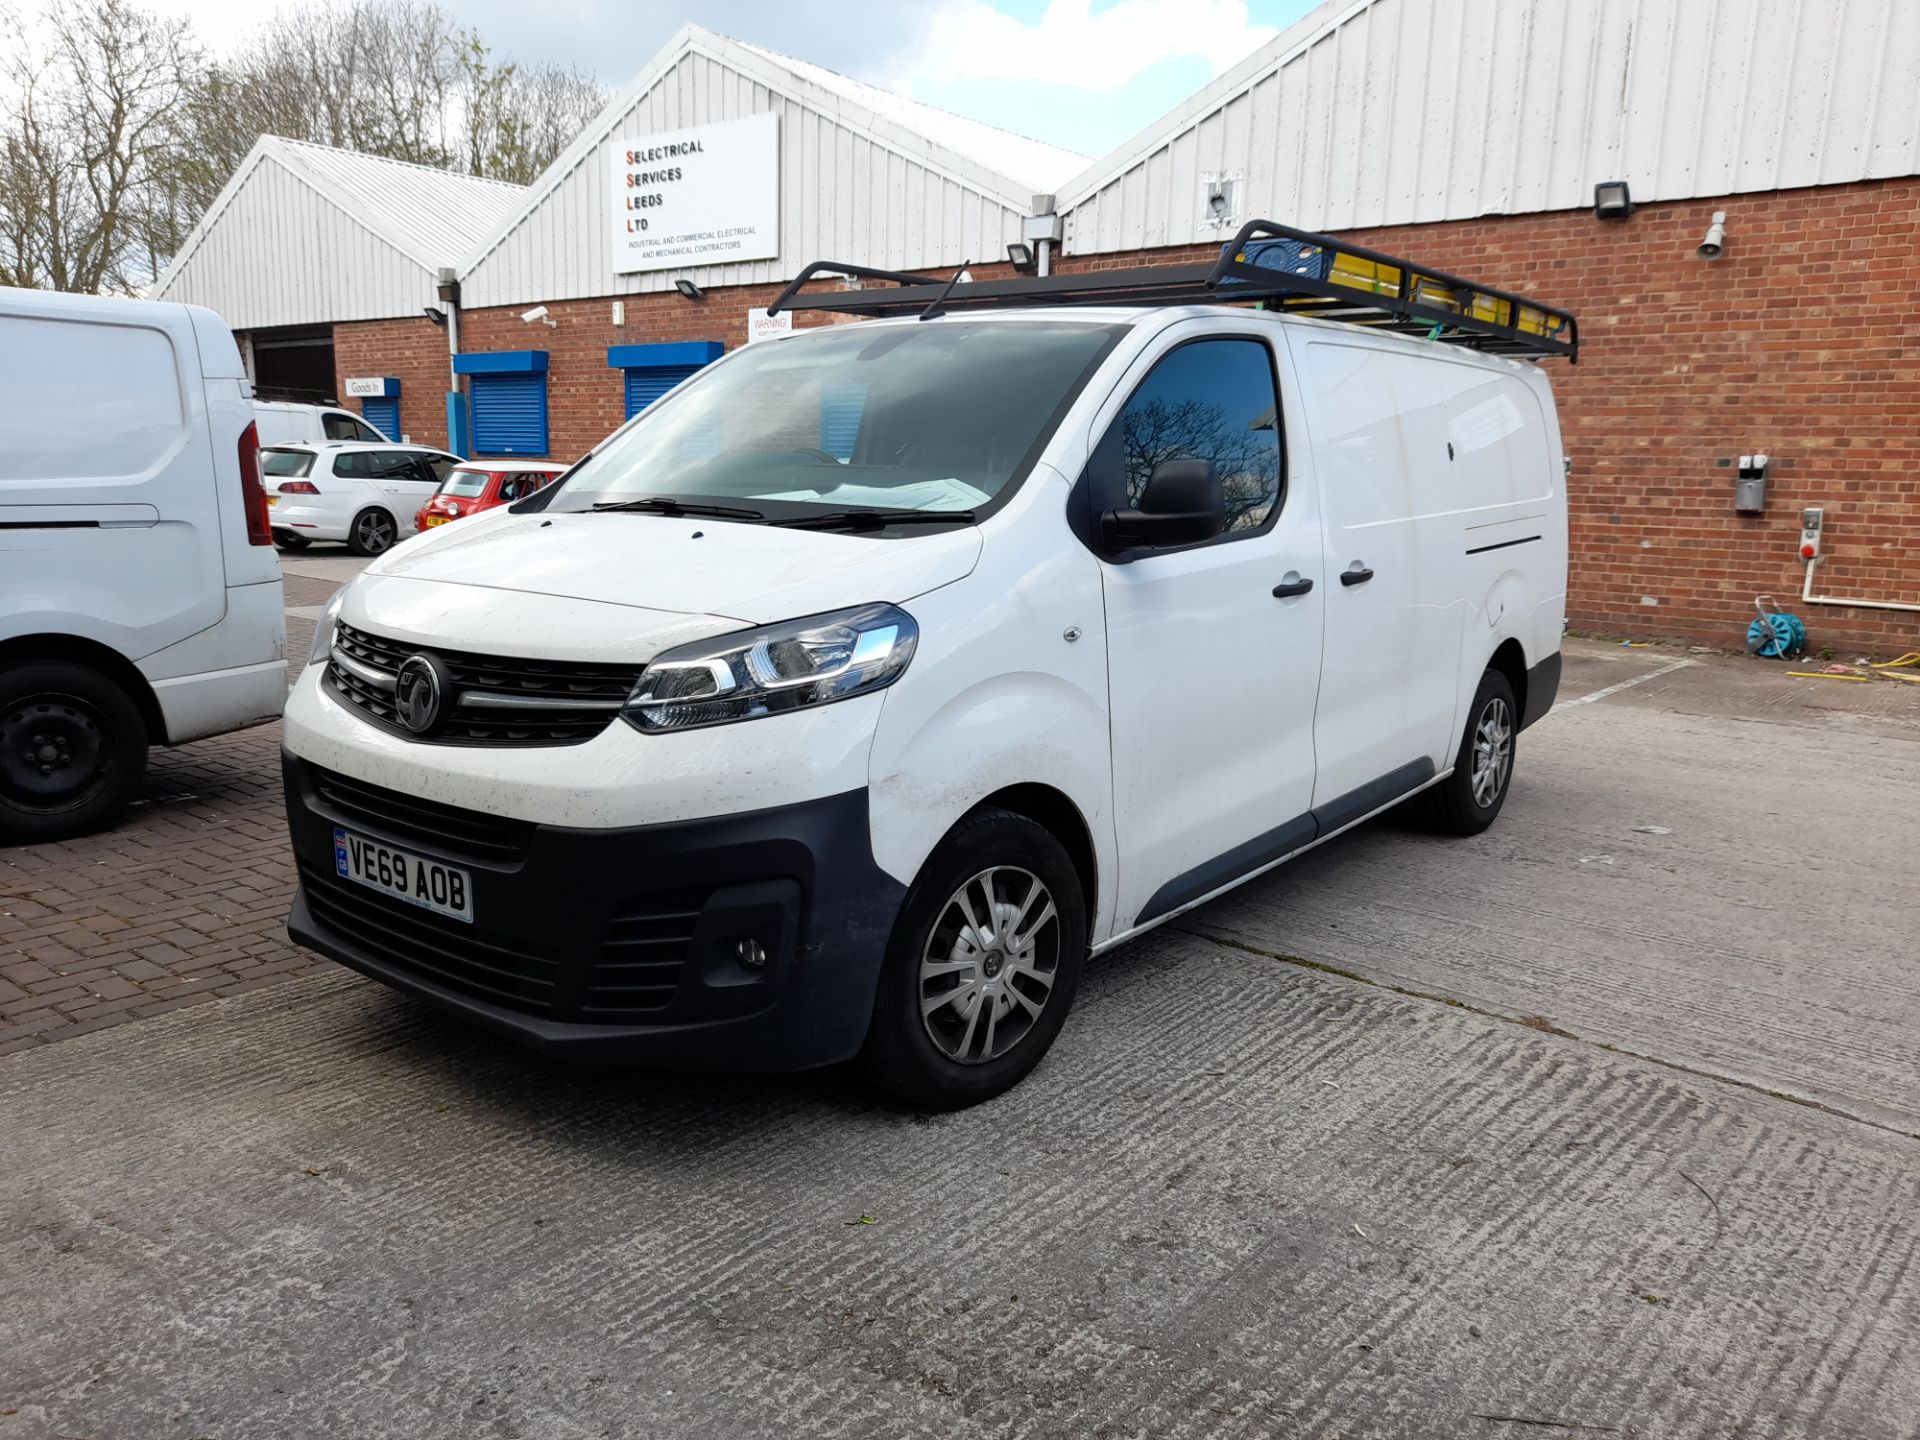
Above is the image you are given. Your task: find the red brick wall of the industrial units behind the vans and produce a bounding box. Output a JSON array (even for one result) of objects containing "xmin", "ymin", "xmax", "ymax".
[{"xmin": 322, "ymin": 179, "xmax": 1920, "ymax": 651}]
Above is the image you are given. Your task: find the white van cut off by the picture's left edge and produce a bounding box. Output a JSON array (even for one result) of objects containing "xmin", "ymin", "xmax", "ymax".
[{"xmin": 0, "ymin": 290, "xmax": 286, "ymax": 843}]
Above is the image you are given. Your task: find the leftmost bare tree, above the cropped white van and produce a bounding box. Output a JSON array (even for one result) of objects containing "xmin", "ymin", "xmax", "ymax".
[{"xmin": 0, "ymin": 0, "xmax": 202, "ymax": 292}]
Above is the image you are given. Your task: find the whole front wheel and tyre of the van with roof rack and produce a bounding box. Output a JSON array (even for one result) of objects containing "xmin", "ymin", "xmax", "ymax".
[{"xmin": 858, "ymin": 810, "xmax": 1087, "ymax": 1110}]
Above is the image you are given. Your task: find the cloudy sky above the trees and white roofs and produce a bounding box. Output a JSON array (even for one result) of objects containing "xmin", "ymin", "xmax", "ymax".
[{"xmin": 150, "ymin": 0, "xmax": 1317, "ymax": 156}]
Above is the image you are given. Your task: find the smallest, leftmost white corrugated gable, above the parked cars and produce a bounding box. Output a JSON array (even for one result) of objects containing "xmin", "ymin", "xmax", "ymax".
[{"xmin": 154, "ymin": 156, "xmax": 439, "ymax": 330}]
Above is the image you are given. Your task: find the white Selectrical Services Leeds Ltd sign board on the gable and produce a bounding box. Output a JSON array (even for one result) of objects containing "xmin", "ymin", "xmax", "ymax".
[{"xmin": 607, "ymin": 115, "xmax": 780, "ymax": 275}]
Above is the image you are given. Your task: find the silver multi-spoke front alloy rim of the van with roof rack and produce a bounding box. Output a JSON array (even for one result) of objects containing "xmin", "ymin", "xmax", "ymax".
[{"xmin": 920, "ymin": 866, "xmax": 1060, "ymax": 1066}]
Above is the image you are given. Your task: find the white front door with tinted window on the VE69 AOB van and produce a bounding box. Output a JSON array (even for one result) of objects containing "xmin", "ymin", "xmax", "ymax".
[{"xmin": 1089, "ymin": 319, "xmax": 1325, "ymax": 929}]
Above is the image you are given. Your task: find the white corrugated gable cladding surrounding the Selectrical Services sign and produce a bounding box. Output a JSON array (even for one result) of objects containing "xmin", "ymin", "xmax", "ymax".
[{"xmin": 461, "ymin": 50, "xmax": 1023, "ymax": 309}]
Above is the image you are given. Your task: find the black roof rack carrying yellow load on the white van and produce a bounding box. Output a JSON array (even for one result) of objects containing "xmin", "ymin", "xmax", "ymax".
[{"xmin": 766, "ymin": 221, "xmax": 1580, "ymax": 361}]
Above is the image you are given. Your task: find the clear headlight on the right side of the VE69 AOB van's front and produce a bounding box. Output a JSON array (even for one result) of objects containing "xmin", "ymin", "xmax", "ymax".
[{"xmin": 622, "ymin": 605, "xmax": 920, "ymax": 732}]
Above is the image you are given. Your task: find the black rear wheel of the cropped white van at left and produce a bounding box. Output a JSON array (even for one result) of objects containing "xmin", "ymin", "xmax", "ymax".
[{"xmin": 0, "ymin": 660, "xmax": 148, "ymax": 845}]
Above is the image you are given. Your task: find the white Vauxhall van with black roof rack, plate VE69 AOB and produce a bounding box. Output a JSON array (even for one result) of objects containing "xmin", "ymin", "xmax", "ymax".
[{"xmin": 286, "ymin": 227, "xmax": 1574, "ymax": 1106}]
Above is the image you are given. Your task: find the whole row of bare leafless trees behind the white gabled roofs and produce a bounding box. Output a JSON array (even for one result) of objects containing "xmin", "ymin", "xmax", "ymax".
[{"xmin": 0, "ymin": 0, "xmax": 607, "ymax": 292}]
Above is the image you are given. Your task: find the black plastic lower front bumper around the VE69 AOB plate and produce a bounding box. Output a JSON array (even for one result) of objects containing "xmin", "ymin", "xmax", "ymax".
[{"xmin": 282, "ymin": 755, "xmax": 904, "ymax": 1071}]
